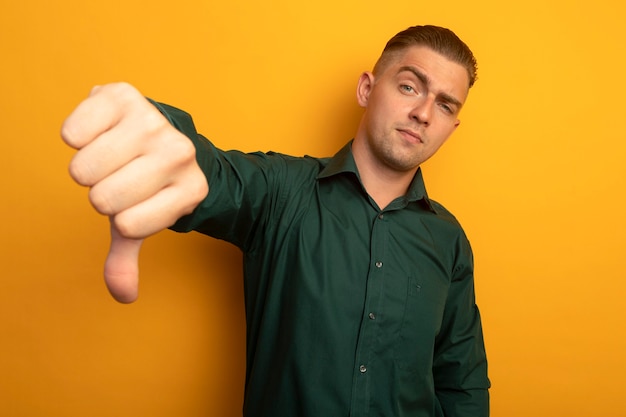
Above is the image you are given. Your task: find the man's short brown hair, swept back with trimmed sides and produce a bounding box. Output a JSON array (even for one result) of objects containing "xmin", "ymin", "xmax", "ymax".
[{"xmin": 374, "ymin": 25, "xmax": 478, "ymax": 88}]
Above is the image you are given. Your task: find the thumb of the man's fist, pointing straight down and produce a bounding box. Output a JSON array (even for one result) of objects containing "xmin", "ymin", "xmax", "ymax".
[{"xmin": 104, "ymin": 221, "xmax": 143, "ymax": 304}]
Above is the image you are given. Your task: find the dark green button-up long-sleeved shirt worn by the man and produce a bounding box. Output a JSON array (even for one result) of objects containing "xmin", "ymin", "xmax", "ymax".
[{"xmin": 158, "ymin": 101, "xmax": 489, "ymax": 417}]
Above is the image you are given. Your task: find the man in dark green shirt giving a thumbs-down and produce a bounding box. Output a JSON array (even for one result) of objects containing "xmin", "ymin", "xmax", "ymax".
[{"xmin": 62, "ymin": 26, "xmax": 489, "ymax": 417}]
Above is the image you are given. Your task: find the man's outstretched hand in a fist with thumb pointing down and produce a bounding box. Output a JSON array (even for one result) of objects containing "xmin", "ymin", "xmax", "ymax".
[{"xmin": 61, "ymin": 83, "xmax": 208, "ymax": 303}]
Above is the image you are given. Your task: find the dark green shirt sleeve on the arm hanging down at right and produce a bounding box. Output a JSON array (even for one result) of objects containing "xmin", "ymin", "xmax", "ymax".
[{"xmin": 433, "ymin": 234, "xmax": 490, "ymax": 417}]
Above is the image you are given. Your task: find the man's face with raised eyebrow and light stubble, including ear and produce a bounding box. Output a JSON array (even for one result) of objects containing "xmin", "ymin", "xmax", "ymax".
[{"xmin": 353, "ymin": 46, "xmax": 469, "ymax": 172}]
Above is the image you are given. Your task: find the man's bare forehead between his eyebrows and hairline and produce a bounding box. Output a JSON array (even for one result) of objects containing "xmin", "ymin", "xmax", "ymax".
[{"xmin": 378, "ymin": 45, "xmax": 469, "ymax": 101}]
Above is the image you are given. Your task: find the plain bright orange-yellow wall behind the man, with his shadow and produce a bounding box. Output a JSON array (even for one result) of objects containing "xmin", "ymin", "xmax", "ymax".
[{"xmin": 0, "ymin": 0, "xmax": 626, "ymax": 417}]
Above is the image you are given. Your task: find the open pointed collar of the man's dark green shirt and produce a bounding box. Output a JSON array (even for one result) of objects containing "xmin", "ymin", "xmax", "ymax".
[{"xmin": 317, "ymin": 141, "xmax": 437, "ymax": 213}]
